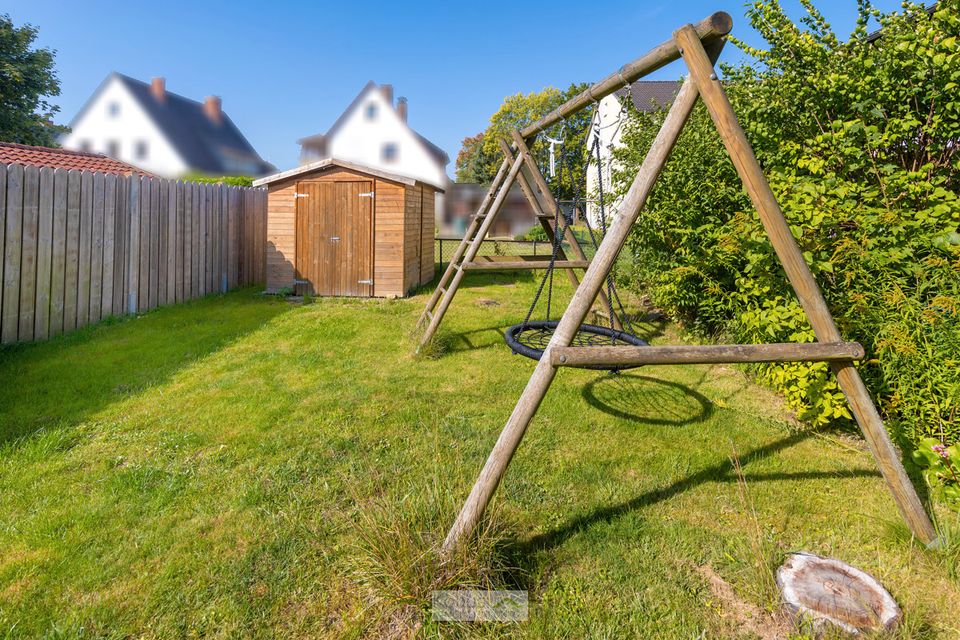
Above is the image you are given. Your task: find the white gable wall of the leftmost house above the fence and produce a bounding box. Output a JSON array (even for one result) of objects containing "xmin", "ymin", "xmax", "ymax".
[{"xmin": 62, "ymin": 77, "xmax": 189, "ymax": 178}]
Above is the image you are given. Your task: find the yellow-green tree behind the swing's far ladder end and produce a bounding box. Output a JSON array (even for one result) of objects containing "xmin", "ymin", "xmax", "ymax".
[{"xmin": 456, "ymin": 84, "xmax": 592, "ymax": 199}]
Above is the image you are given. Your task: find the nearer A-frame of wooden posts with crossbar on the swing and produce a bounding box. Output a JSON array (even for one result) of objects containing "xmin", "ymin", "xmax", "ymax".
[{"xmin": 444, "ymin": 14, "xmax": 936, "ymax": 551}]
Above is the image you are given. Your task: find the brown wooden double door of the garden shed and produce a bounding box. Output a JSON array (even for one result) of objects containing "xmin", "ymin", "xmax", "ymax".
[{"xmin": 296, "ymin": 181, "xmax": 373, "ymax": 296}]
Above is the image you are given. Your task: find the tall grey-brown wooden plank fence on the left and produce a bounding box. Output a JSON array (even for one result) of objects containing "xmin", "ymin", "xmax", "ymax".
[{"xmin": 0, "ymin": 164, "xmax": 267, "ymax": 344}]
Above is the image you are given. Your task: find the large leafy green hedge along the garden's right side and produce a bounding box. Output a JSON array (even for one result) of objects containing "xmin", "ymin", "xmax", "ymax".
[{"xmin": 615, "ymin": 0, "xmax": 960, "ymax": 444}]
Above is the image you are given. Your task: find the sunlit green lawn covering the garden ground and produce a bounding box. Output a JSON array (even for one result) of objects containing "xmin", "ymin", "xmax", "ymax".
[{"xmin": 0, "ymin": 275, "xmax": 960, "ymax": 638}]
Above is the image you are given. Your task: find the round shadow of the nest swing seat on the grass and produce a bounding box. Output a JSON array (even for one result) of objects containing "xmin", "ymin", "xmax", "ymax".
[{"xmin": 580, "ymin": 373, "xmax": 714, "ymax": 427}]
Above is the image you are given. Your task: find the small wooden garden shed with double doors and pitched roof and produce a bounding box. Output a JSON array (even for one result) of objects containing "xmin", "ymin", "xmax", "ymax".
[{"xmin": 254, "ymin": 159, "xmax": 441, "ymax": 297}]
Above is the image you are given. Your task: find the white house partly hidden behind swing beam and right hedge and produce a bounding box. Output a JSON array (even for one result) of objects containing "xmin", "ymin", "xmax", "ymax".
[{"xmin": 587, "ymin": 80, "xmax": 680, "ymax": 226}]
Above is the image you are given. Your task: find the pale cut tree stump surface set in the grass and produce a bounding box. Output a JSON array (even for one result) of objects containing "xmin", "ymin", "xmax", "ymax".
[{"xmin": 777, "ymin": 553, "xmax": 901, "ymax": 633}]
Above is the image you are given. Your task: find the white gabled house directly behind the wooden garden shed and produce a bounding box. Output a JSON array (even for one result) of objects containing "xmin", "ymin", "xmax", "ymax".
[{"xmin": 297, "ymin": 81, "xmax": 450, "ymax": 213}]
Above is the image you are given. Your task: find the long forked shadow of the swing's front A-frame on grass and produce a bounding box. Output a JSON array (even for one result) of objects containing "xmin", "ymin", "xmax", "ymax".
[{"xmin": 502, "ymin": 432, "xmax": 880, "ymax": 575}]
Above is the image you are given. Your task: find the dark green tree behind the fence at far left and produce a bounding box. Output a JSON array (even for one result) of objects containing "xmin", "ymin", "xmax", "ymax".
[{"xmin": 0, "ymin": 14, "xmax": 68, "ymax": 147}]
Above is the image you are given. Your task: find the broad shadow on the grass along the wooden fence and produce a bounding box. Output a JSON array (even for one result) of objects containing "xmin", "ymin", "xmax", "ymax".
[{"xmin": 0, "ymin": 289, "xmax": 292, "ymax": 446}]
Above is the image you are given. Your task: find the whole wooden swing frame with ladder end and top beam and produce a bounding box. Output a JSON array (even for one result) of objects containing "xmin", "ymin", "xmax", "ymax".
[{"xmin": 421, "ymin": 12, "xmax": 937, "ymax": 551}]
